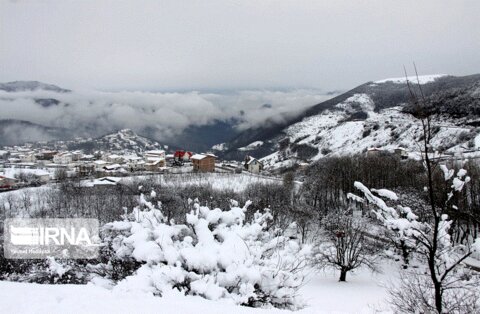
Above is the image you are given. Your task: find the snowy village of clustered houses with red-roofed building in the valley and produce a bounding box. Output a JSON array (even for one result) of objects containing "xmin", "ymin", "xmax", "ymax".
[{"xmin": 0, "ymin": 130, "xmax": 274, "ymax": 191}]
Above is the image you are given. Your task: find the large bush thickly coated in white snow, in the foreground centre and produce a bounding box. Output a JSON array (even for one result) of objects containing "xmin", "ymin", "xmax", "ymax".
[{"xmin": 104, "ymin": 196, "xmax": 310, "ymax": 309}]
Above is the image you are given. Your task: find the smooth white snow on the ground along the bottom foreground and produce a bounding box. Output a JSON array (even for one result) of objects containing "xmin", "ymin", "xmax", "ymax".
[{"xmin": 0, "ymin": 265, "xmax": 396, "ymax": 314}]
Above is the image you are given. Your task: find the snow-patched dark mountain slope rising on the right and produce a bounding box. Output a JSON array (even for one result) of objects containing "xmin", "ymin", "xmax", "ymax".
[{"xmin": 219, "ymin": 75, "xmax": 480, "ymax": 168}]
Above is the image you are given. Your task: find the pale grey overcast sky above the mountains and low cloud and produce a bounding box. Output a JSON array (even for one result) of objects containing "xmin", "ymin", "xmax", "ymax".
[{"xmin": 0, "ymin": 0, "xmax": 480, "ymax": 91}]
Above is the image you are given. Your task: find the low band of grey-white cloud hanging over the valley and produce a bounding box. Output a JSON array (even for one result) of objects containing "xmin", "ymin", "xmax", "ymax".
[{"xmin": 0, "ymin": 90, "xmax": 331, "ymax": 140}]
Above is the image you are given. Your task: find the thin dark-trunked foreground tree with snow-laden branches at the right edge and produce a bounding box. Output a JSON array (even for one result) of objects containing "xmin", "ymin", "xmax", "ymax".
[{"xmin": 355, "ymin": 165, "xmax": 480, "ymax": 313}]
